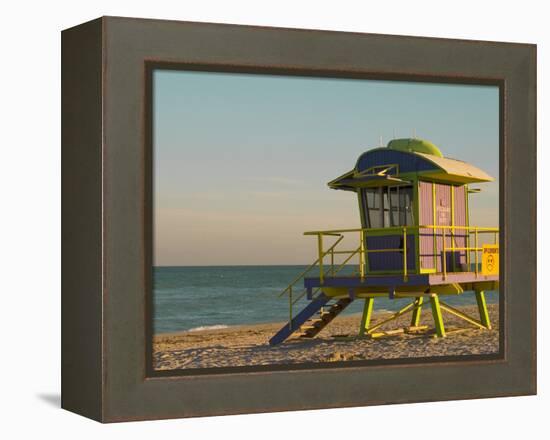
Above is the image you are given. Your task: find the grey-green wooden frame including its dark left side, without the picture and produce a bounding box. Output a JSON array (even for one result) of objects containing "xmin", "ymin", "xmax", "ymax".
[{"xmin": 62, "ymin": 17, "xmax": 536, "ymax": 422}]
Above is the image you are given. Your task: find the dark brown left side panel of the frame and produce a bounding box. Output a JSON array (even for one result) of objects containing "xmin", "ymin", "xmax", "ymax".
[{"xmin": 61, "ymin": 18, "xmax": 104, "ymax": 421}]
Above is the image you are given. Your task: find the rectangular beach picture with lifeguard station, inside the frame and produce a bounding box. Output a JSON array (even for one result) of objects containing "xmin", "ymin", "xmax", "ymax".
[{"xmin": 151, "ymin": 68, "xmax": 502, "ymax": 371}]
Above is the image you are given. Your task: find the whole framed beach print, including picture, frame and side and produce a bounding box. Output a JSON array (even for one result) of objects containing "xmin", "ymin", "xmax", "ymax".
[{"xmin": 62, "ymin": 17, "xmax": 536, "ymax": 422}]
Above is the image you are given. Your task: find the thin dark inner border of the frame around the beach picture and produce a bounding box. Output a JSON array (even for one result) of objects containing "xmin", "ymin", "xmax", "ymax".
[{"xmin": 143, "ymin": 61, "xmax": 508, "ymax": 378}]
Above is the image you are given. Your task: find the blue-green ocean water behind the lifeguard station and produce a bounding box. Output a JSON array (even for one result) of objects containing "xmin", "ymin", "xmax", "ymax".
[{"xmin": 153, "ymin": 266, "xmax": 498, "ymax": 334}]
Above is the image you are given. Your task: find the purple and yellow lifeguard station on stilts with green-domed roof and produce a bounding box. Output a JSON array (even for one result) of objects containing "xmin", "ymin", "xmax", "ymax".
[{"xmin": 269, "ymin": 139, "xmax": 499, "ymax": 345}]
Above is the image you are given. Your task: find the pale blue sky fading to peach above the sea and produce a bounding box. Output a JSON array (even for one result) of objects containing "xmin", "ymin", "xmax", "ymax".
[{"xmin": 153, "ymin": 70, "xmax": 499, "ymax": 265}]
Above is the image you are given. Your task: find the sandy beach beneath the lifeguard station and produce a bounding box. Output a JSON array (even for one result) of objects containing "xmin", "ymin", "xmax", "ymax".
[{"xmin": 153, "ymin": 305, "xmax": 499, "ymax": 370}]
